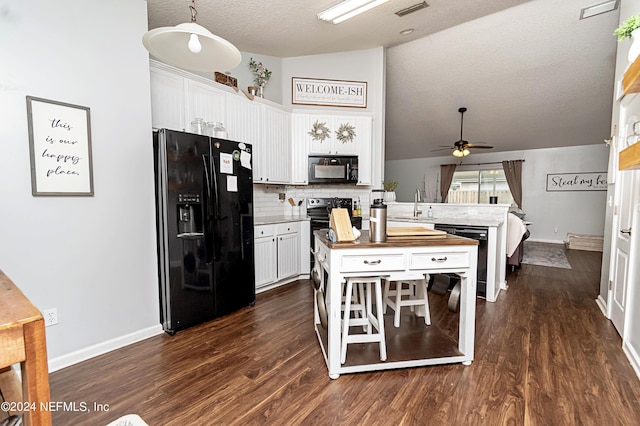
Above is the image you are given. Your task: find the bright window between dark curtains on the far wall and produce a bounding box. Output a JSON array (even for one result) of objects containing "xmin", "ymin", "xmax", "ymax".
[{"xmin": 447, "ymin": 169, "xmax": 513, "ymax": 204}]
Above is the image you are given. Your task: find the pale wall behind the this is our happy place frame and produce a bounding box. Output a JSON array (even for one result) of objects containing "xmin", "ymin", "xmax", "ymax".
[{"xmin": 0, "ymin": 0, "xmax": 161, "ymax": 369}]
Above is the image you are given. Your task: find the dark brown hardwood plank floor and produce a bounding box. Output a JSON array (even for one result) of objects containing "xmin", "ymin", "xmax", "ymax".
[{"xmin": 45, "ymin": 250, "xmax": 640, "ymax": 426}]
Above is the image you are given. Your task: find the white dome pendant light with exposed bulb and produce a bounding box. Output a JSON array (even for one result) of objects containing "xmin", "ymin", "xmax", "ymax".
[{"xmin": 142, "ymin": 0, "xmax": 242, "ymax": 72}]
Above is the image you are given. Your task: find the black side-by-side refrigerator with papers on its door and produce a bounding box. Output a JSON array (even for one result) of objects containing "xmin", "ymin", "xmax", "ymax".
[{"xmin": 153, "ymin": 129, "xmax": 255, "ymax": 335}]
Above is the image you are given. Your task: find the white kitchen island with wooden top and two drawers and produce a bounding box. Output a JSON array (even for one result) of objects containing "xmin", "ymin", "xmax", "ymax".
[{"xmin": 314, "ymin": 230, "xmax": 478, "ymax": 379}]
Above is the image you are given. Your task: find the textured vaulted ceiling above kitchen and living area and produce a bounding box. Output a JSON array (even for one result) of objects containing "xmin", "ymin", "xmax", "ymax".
[{"xmin": 147, "ymin": 0, "xmax": 618, "ymax": 160}]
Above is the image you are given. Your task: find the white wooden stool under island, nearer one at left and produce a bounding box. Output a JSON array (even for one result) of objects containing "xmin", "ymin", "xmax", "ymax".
[{"xmin": 340, "ymin": 277, "xmax": 387, "ymax": 364}]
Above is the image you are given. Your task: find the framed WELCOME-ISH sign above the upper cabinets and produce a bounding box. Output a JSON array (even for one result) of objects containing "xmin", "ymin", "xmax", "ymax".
[{"xmin": 291, "ymin": 77, "xmax": 367, "ymax": 108}]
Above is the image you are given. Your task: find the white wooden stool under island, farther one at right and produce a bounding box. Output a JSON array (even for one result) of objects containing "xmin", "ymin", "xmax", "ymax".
[{"xmin": 382, "ymin": 273, "xmax": 431, "ymax": 327}]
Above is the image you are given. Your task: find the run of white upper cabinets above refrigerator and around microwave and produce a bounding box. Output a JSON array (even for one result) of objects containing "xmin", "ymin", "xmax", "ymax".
[{"xmin": 150, "ymin": 60, "xmax": 380, "ymax": 185}]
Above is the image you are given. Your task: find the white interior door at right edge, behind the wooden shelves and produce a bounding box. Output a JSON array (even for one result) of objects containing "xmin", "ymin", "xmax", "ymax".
[{"xmin": 609, "ymin": 105, "xmax": 640, "ymax": 337}]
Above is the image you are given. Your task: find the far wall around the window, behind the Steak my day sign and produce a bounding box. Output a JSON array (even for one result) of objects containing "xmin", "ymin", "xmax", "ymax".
[{"xmin": 385, "ymin": 143, "xmax": 609, "ymax": 243}]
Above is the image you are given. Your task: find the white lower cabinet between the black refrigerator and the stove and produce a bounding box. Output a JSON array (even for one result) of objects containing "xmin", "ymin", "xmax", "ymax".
[{"xmin": 254, "ymin": 222, "xmax": 303, "ymax": 290}]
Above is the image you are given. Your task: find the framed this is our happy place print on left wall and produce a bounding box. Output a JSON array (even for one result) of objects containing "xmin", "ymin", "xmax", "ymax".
[{"xmin": 26, "ymin": 96, "xmax": 94, "ymax": 196}]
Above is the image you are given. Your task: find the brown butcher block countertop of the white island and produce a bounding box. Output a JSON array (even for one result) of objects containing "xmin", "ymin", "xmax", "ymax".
[{"xmin": 313, "ymin": 229, "xmax": 478, "ymax": 249}]
